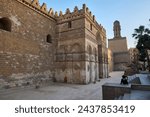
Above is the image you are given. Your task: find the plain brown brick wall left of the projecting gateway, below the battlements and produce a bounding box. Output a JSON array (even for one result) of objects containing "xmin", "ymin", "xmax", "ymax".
[{"xmin": 0, "ymin": 0, "xmax": 56, "ymax": 77}]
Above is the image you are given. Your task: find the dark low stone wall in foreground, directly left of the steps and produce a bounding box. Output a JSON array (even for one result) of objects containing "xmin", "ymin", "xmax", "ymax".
[{"xmin": 102, "ymin": 83, "xmax": 131, "ymax": 100}]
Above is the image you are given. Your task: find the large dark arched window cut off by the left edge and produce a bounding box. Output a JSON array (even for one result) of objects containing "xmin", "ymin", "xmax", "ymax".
[{"xmin": 0, "ymin": 17, "xmax": 11, "ymax": 32}]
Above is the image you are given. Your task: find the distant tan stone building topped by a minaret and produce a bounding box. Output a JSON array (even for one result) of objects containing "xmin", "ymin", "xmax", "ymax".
[{"xmin": 108, "ymin": 21, "xmax": 129, "ymax": 71}]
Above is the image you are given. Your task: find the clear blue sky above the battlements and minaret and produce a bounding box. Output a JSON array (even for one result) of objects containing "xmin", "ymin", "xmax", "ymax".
[{"xmin": 39, "ymin": 0, "xmax": 150, "ymax": 48}]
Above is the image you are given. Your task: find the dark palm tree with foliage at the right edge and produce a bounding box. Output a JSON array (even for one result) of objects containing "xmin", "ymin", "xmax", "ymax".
[{"xmin": 132, "ymin": 23, "xmax": 150, "ymax": 71}]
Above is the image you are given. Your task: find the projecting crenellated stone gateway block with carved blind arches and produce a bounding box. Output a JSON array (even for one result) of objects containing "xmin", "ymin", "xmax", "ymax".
[{"xmin": 55, "ymin": 4, "xmax": 108, "ymax": 84}]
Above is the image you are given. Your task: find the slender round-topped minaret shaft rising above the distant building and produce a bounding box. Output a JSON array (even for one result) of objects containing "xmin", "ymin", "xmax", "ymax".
[{"xmin": 113, "ymin": 20, "xmax": 121, "ymax": 38}]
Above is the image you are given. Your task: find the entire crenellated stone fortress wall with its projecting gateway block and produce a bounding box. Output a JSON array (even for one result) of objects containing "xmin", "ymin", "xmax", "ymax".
[{"xmin": 0, "ymin": 0, "xmax": 108, "ymax": 88}]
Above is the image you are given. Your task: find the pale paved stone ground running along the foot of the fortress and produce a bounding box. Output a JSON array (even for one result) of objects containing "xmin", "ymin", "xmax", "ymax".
[{"xmin": 0, "ymin": 72, "xmax": 123, "ymax": 100}]
